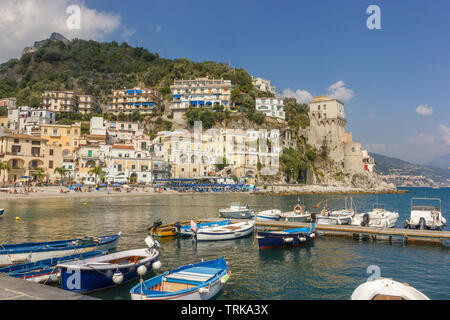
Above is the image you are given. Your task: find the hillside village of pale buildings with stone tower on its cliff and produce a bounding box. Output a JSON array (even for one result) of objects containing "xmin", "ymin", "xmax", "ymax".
[{"xmin": 0, "ymin": 35, "xmax": 395, "ymax": 191}]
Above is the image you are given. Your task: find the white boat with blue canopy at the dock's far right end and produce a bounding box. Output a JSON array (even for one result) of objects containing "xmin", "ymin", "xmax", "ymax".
[{"xmin": 404, "ymin": 198, "xmax": 447, "ymax": 230}]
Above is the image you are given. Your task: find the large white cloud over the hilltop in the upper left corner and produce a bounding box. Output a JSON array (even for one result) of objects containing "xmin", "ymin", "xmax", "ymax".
[{"xmin": 0, "ymin": 0, "xmax": 121, "ymax": 62}]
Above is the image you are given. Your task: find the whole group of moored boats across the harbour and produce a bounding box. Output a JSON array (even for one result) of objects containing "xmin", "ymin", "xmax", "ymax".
[{"xmin": 0, "ymin": 198, "xmax": 446, "ymax": 300}]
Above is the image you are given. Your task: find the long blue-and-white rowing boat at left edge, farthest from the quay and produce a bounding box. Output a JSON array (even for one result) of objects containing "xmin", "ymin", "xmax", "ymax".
[{"xmin": 0, "ymin": 232, "xmax": 122, "ymax": 267}]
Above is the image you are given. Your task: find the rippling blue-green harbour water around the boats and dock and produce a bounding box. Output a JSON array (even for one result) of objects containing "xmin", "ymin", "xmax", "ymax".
[{"xmin": 0, "ymin": 188, "xmax": 450, "ymax": 300}]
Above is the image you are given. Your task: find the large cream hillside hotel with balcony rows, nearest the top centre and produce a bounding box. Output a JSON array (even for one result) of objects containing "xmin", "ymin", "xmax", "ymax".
[{"xmin": 170, "ymin": 78, "xmax": 231, "ymax": 111}]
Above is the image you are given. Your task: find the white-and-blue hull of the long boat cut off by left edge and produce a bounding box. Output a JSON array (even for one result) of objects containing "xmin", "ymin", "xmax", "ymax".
[{"xmin": 0, "ymin": 235, "xmax": 120, "ymax": 267}]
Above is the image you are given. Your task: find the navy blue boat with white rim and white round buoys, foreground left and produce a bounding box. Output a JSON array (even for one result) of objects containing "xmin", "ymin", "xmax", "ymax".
[{"xmin": 57, "ymin": 236, "xmax": 161, "ymax": 293}]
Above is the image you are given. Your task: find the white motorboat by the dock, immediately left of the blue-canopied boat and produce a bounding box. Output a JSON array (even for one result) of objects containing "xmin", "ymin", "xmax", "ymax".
[{"xmin": 350, "ymin": 203, "xmax": 399, "ymax": 228}]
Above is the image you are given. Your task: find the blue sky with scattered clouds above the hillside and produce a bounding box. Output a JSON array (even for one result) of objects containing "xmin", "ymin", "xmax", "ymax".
[{"xmin": 0, "ymin": 0, "xmax": 450, "ymax": 164}]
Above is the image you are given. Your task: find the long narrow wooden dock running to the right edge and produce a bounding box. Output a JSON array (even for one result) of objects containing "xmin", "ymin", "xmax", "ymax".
[{"xmin": 204, "ymin": 218, "xmax": 450, "ymax": 244}]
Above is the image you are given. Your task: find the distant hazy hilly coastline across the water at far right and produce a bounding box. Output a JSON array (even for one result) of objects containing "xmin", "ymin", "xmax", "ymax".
[{"xmin": 370, "ymin": 153, "xmax": 450, "ymax": 183}]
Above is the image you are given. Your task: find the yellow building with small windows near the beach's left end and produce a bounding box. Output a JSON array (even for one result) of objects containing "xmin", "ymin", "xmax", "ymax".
[{"xmin": 41, "ymin": 123, "xmax": 81, "ymax": 156}]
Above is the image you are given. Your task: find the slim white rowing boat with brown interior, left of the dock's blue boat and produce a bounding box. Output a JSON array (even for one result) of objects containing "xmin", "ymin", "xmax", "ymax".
[{"xmin": 196, "ymin": 220, "xmax": 255, "ymax": 241}]
